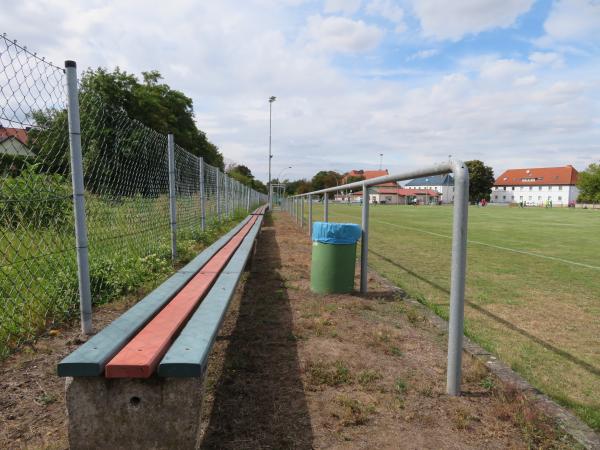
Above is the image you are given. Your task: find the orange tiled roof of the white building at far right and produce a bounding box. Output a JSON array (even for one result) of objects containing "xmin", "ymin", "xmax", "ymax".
[{"xmin": 494, "ymin": 165, "xmax": 578, "ymax": 186}]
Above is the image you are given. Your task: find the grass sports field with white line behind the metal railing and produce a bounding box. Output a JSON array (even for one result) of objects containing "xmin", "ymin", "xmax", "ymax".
[{"xmin": 304, "ymin": 205, "xmax": 600, "ymax": 430}]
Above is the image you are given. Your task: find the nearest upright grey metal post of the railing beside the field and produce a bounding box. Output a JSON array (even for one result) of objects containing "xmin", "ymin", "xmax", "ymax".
[{"xmin": 446, "ymin": 162, "xmax": 469, "ymax": 395}]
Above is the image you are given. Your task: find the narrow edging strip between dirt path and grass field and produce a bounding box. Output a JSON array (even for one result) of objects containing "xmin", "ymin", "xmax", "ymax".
[{"xmin": 369, "ymin": 268, "xmax": 600, "ymax": 449}]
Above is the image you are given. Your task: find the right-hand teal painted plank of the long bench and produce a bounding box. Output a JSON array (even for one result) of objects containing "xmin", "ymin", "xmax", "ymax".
[{"xmin": 158, "ymin": 217, "xmax": 263, "ymax": 377}]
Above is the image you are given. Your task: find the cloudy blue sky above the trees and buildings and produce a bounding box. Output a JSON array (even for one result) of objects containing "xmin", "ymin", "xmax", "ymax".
[{"xmin": 0, "ymin": 0, "xmax": 600, "ymax": 180}]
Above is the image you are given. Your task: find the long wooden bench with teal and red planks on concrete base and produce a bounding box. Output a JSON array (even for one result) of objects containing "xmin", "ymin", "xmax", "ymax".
[{"xmin": 58, "ymin": 206, "xmax": 266, "ymax": 448}]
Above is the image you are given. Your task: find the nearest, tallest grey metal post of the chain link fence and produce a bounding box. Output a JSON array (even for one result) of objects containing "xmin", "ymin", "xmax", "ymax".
[{"xmin": 65, "ymin": 61, "xmax": 93, "ymax": 335}]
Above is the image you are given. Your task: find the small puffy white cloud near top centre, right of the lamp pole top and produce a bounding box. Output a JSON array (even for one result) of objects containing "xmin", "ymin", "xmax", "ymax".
[{"xmin": 307, "ymin": 15, "xmax": 383, "ymax": 53}]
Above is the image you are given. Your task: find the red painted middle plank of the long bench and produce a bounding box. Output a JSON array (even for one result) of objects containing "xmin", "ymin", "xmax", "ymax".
[{"xmin": 105, "ymin": 217, "xmax": 256, "ymax": 378}]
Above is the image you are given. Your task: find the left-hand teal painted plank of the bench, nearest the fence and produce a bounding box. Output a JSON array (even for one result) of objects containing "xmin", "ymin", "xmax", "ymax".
[{"xmin": 57, "ymin": 216, "xmax": 250, "ymax": 377}]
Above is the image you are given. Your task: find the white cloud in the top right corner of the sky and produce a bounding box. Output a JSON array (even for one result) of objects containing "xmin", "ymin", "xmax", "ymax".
[{"xmin": 544, "ymin": 0, "xmax": 600, "ymax": 44}]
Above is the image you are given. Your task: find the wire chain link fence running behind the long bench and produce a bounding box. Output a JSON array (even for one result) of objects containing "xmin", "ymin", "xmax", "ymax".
[{"xmin": 0, "ymin": 35, "xmax": 265, "ymax": 358}]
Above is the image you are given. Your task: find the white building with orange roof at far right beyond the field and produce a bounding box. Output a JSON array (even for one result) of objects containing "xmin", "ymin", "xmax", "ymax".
[{"xmin": 491, "ymin": 165, "xmax": 579, "ymax": 206}]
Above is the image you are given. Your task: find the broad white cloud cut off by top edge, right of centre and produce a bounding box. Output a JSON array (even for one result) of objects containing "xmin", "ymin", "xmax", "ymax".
[{"xmin": 412, "ymin": 0, "xmax": 534, "ymax": 40}]
